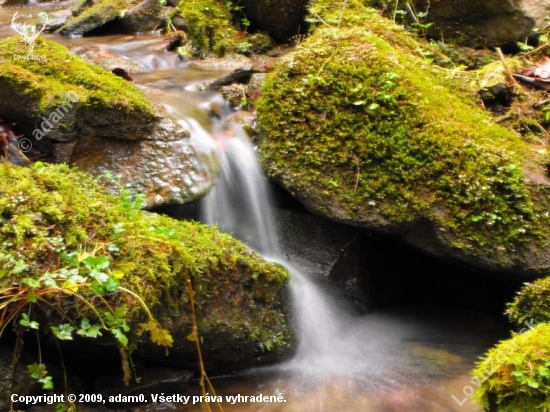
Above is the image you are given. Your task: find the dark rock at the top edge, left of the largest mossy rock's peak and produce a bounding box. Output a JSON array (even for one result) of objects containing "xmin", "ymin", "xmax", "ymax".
[{"xmin": 239, "ymin": 0, "xmax": 309, "ymax": 42}]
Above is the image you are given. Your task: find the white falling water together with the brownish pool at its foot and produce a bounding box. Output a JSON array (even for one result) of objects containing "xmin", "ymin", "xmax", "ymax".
[{"xmin": 195, "ymin": 127, "xmax": 492, "ymax": 412}]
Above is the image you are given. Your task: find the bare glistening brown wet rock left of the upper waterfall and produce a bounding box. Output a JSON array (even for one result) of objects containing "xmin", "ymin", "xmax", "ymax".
[{"xmin": 71, "ymin": 120, "xmax": 217, "ymax": 208}]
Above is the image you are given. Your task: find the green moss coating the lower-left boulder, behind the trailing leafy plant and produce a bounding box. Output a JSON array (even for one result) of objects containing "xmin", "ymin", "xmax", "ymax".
[{"xmin": 0, "ymin": 163, "xmax": 289, "ymax": 349}]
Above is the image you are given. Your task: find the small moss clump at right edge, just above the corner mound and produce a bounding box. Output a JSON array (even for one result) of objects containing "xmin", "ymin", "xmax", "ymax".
[{"xmin": 506, "ymin": 277, "xmax": 550, "ymax": 327}]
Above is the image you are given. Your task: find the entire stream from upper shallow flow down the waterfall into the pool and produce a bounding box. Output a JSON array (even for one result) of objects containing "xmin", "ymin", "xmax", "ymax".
[{"xmin": 0, "ymin": 4, "xmax": 506, "ymax": 412}]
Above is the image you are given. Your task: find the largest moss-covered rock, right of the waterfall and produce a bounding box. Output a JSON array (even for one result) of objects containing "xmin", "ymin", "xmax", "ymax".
[{"xmin": 258, "ymin": 1, "xmax": 550, "ymax": 275}]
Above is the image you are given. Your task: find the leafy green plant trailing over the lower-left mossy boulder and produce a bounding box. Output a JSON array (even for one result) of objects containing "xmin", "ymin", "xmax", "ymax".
[{"xmin": 0, "ymin": 248, "xmax": 172, "ymax": 400}]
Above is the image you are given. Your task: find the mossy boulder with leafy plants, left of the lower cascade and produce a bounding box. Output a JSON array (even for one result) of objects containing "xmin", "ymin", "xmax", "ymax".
[{"xmin": 0, "ymin": 163, "xmax": 290, "ymax": 372}]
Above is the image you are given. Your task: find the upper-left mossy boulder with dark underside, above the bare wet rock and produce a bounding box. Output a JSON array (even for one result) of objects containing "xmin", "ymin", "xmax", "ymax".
[{"xmin": 0, "ymin": 36, "xmax": 157, "ymax": 141}]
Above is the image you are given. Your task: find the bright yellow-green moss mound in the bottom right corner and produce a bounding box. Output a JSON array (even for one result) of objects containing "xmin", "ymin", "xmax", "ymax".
[{"xmin": 473, "ymin": 323, "xmax": 550, "ymax": 412}]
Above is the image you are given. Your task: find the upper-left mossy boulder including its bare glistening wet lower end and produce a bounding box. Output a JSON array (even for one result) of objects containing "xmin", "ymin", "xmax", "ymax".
[{"xmin": 0, "ymin": 36, "xmax": 217, "ymax": 208}]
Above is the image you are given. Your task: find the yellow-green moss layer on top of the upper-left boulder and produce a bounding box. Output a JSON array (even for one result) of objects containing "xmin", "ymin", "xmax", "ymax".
[{"xmin": 0, "ymin": 36, "xmax": 154, "ymax": 119}]
